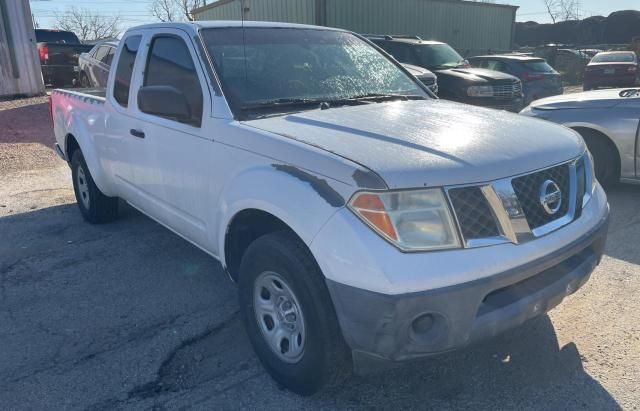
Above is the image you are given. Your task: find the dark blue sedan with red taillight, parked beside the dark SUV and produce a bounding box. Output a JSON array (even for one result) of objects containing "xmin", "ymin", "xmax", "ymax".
[{"xmin": 469, "ymin": 54, "xmax": 564, "ymax": 105}]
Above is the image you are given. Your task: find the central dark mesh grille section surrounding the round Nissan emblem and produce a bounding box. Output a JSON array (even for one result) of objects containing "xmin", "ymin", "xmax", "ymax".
[{"xmin": 511, "ymin": 164, "xmax": 573, "ymax": 229}]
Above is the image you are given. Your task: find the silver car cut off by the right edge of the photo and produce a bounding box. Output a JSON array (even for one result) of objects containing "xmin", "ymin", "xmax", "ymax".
[{"xmin": 521, "ymin": 89, "xmax": 640, "ymax": 187}]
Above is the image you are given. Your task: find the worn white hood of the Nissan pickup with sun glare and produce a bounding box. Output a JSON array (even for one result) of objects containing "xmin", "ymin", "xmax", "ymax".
[{"xmin": 244, "ymin": 100, "xmax": 584, "ymax": 188}]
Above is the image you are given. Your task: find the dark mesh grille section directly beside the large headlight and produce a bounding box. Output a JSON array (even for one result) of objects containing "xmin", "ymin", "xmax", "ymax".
[{"xmin": 449, "ymin": 187, "xmax": 500, "ymax": 240}]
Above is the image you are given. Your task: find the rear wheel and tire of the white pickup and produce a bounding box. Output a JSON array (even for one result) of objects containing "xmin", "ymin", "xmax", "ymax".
[{"xmin": 71, "ymin": 150, "xmax": 118, "ymax": 224}]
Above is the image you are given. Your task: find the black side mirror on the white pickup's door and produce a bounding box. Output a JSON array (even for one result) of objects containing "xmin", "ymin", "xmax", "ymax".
[{"xmin": 138, "ymin": 86, "xmax": 191, "ymax": 123}]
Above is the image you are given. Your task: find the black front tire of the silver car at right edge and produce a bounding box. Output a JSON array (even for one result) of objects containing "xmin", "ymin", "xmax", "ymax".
[{"xmin": 578, "ymin": 130, "xmax": 620, "ymax": 188}]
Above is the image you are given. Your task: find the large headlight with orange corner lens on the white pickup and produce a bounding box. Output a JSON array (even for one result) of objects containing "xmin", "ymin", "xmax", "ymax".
[{"xmin": 349, "ymin": 189, "xmax": 460, "ymax": 251}]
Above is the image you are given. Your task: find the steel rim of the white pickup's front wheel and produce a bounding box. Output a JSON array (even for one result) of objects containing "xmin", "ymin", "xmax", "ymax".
[{"xmin": 253, "ymin": 271, "xmax": 306, "ymax": 363}]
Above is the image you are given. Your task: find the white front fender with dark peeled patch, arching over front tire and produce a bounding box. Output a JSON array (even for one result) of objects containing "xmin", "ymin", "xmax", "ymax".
[{"xmin": 212, "ymin": 164, "xmax": 353, "ymax": 280}]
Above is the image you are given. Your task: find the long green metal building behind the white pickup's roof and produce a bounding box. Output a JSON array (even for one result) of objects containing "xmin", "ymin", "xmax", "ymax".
[{"xmin": 193, "ymin": 0, "xmax": 518, "ymax": 54}]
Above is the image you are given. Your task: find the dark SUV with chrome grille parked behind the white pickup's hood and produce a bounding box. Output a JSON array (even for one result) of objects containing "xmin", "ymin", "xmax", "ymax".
[{"xmin": 365, "ymin": 35, "xmax": 524, "ymax": 112}]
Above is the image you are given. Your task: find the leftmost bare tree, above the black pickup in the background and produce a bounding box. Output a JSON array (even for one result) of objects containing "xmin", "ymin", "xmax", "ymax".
[{"xmin": 55, "ymin": 6, "xmax": 121, "ymax": 41}]
